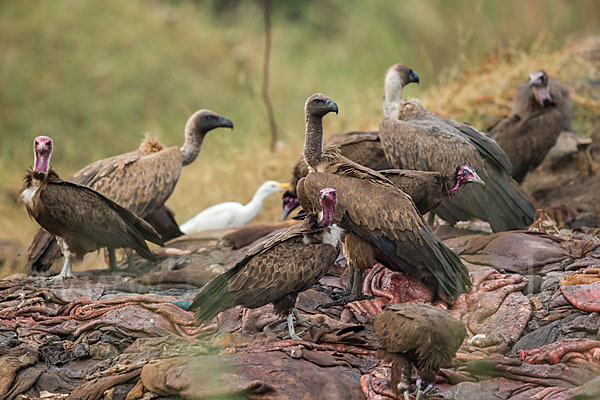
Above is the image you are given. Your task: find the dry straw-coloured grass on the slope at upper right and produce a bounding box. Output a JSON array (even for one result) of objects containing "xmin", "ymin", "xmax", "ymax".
[{"xmin": 423, "ymin": 37, "xmax": 600, "ymax": 131}]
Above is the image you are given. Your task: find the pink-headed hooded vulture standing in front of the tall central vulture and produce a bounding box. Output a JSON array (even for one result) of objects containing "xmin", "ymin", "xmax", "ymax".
[{"xmin": 190, "ymin": 188, "xmax": 343, "ymax": 339}]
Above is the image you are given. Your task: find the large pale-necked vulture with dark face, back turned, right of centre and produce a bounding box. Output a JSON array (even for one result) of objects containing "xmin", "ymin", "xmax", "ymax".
[{"xmin": 379, "ymin": 64, "xmax": 536, "ymax": 232}]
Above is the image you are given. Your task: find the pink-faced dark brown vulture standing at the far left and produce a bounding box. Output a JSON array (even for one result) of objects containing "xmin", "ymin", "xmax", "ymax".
[{"xmin": 20, "ymin": 136, "xmax": 164, "ymax": 279}]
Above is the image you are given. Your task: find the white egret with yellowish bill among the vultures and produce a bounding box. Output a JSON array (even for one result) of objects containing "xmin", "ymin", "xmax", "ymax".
[{"xmin": 181, "ymin": 181, "xmax": 290, "ymax": 234}]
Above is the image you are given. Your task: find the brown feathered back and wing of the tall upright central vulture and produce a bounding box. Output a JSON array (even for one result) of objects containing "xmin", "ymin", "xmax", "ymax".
[{"xmin": 297, "ymin": 166, "xmax": 470, "ymax": 297}]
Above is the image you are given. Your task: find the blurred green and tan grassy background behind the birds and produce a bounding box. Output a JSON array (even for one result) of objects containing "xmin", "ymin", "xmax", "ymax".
[{"xmin": 0, "ymin": 0, "xmax": 600, "ymax": 276}]
